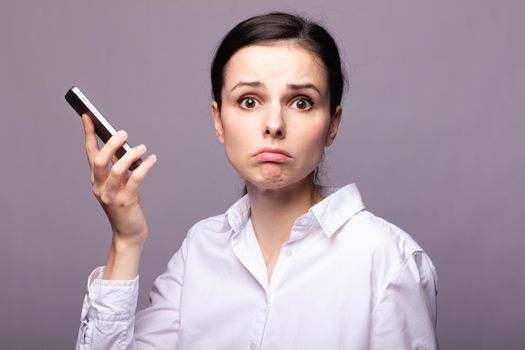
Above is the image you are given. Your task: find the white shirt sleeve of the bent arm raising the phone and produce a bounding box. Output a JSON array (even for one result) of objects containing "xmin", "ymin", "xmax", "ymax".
[{"xmin": 76, "ymin": 239, "xmax": 187, "ymax": 350}]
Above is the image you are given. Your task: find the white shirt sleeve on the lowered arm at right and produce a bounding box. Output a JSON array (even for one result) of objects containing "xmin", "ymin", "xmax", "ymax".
[{"xmin": 371, "ymin": 251, "xmax": 438, "ymax": 350}]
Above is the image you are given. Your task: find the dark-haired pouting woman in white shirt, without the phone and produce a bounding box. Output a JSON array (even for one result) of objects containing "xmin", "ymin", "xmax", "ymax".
[{"xmin": 77, "ymin": 13, "xmax": 437, "ymax": 350}]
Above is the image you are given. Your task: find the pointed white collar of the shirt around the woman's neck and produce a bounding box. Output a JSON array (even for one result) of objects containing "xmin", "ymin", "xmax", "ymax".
[{"xmin": 226, "ymin": 183, "xmax": 365, "ymax": 237}]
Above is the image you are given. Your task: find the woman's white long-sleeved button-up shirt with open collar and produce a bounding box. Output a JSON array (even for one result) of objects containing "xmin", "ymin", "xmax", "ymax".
[{"xmin": 77, "ymin": 184, "xmax": 438, "ymax": 350}]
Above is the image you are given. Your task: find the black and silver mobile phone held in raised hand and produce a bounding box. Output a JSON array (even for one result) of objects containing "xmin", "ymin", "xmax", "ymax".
[{"xmin": 65, "ymin": 86, "xmax": 142, "ymax": 170}]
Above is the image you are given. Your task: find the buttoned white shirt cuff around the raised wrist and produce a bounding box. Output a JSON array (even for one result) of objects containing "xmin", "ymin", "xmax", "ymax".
[{"xmin": 82, "ymin": 266, "xmax": 139, "ymax": 321}]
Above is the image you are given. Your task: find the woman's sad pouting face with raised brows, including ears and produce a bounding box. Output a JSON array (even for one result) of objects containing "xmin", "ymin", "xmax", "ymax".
[{"xmin": 212, "ymin": 40, "xmax": 341, "ymax": 189}]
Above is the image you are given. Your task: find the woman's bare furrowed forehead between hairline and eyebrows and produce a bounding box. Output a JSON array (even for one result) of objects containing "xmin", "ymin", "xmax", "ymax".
[{"xmin": 223, "ymin": 40, "xmax": 327, "ymax": 92}]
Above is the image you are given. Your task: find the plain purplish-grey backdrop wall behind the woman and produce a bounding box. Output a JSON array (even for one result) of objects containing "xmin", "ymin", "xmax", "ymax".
[{"xmin": 0, "ymin": 0, "xmax": 525, "ymax": 349}]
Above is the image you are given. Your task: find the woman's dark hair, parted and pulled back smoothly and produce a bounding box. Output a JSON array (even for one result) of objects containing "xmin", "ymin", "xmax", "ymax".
[{"xmin": 211, "ymin": 12, "xmax": 346, "ymax": 116}]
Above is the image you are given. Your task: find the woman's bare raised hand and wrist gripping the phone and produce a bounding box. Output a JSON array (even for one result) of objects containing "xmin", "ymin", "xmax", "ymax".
[{"xmin": 82, "ymin": 114, "xmax": 157, "ymax": 278}]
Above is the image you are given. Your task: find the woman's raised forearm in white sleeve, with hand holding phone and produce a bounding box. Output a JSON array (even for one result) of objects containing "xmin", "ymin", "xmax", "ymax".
[{"xmin": 77, "ymin": 115, "xmax": 156, "ymax": 349}]
